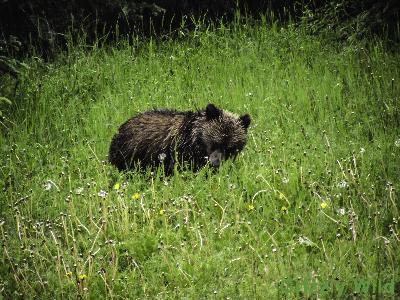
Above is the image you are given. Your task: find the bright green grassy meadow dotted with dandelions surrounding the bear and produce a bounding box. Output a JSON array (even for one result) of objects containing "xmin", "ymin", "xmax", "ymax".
[{"xmin": 0, "ymin": 19, "xmax": 400, "ymax": 299}]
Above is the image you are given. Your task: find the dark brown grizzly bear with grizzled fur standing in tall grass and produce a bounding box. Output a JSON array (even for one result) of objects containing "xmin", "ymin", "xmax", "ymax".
[{"xmin": 108, "ymin": 104, "xmax": 250, "ymax": 175}]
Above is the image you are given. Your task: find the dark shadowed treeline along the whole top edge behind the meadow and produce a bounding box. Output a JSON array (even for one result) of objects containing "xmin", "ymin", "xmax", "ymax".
[{"xmin": 0, "ymin": 0, "xmax": 400, "ymax": 57}]
